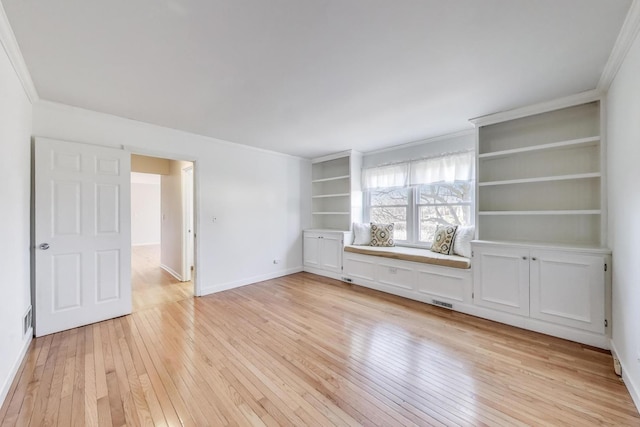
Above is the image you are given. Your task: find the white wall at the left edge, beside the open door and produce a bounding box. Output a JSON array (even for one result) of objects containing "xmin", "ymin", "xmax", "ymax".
[{"xmin": 0, "ymin": 35, "xmax": 32, "ymax": 405}]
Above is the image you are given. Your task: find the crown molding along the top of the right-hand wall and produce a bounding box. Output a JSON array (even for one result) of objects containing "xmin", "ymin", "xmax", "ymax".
[{"xmin": 597, "ymin": 0, "xmax": 640, "ymax": 92}]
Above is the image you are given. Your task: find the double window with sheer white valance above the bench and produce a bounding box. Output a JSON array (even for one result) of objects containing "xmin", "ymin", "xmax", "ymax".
[{"xmin": 363, "ymin": 152, "xmax": 475, "ymax": 246}]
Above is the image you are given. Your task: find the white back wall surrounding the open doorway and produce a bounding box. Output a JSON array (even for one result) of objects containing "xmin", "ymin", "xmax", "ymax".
[{"xmin": 34, "ymin": 102, "xmax": 311, "ymax": 294}]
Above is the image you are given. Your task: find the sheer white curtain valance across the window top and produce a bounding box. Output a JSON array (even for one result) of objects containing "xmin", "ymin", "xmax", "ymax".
[{"xmin": 362, "ymin": 151, "xmax": 475, "ymax": 190}]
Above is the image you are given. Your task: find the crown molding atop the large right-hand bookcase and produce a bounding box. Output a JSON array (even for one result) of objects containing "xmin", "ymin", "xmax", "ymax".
[{"xmin": 469, "ymin": 89, "xmax": 602, "ymax": 127}]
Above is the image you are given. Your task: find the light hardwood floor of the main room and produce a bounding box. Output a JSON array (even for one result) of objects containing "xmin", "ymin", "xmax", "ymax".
[{"xmin": 0, "ymin": 273, "xmax": 640, "ymax": 426}]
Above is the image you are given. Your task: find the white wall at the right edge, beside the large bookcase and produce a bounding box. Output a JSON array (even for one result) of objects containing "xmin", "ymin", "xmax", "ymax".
[{"xmin": 607, "ymin": 25, "xmax": 640, "ymax": 407}]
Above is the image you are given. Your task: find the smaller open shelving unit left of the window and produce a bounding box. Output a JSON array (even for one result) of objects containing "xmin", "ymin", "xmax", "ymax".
[{"xmin": 311, "ymin": 151, "xmax": 362, "ymax": 231}]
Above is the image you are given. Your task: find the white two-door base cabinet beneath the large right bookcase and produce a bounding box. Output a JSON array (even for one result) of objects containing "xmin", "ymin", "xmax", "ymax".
[{"xmin": 473, "ymin": 241, "xmax": 609, "ymax": 340}]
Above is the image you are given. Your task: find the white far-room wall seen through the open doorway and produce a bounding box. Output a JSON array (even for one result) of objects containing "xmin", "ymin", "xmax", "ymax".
[{"xmin": 131, "ymin": 172, "xmax": 160, "ymax": 246}]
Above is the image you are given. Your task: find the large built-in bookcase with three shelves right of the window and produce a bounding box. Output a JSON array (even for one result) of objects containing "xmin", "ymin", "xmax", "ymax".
[{"xmin": 474, "ymin": 98, "xmax": 605, "ymax": 247}]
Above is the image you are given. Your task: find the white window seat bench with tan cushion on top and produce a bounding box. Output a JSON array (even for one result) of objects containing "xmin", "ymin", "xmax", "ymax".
[{"xmin": 342, "ymin": 245, "xmax": 473, "ymax": 311}]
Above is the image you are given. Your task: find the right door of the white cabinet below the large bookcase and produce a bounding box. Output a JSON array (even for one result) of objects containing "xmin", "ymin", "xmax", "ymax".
[{"xmin": 531, "ymin": 251, "xmax": 605, "ymax": 333}]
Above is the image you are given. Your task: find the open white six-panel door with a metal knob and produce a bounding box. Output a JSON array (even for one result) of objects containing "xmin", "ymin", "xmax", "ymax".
[{"xmin": 34, "ymin": 138, "xmax": 131, "ymax": 336}]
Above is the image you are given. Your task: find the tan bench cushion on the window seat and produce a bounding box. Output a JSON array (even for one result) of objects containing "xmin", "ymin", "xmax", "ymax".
[{"xmin": 344, "ymin": 245, "xmax": 471, "ymax": 268}]
